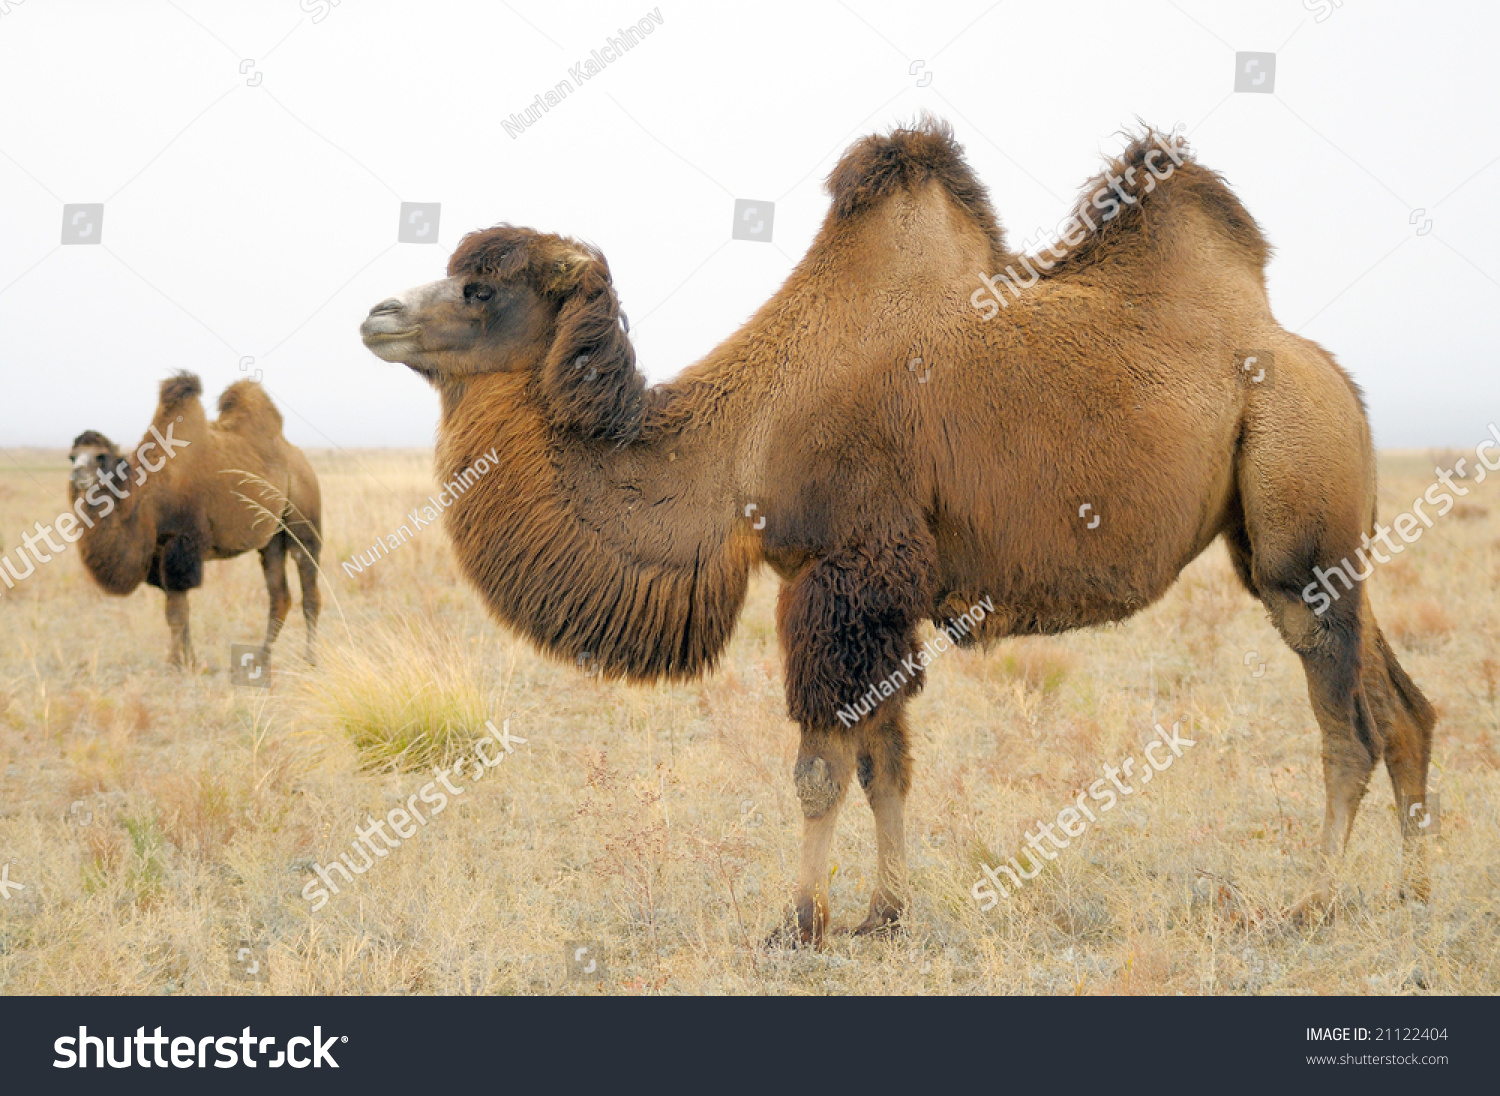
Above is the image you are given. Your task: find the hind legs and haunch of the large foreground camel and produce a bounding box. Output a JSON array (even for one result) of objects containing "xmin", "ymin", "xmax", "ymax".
[{"xmin": 1226, "ymin": 368, "xmax": 1436, "ymax": 916}]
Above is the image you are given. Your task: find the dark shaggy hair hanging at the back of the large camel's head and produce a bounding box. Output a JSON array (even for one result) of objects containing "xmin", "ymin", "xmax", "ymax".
[{"xmin": 542, "ymin": 253, "xmax": 645, "ymax": 442}]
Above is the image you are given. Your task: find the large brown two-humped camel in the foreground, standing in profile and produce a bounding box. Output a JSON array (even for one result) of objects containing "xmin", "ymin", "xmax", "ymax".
[{"xmin": 362, "ymin": 121, "xmax": 1434, "ymax": 942}]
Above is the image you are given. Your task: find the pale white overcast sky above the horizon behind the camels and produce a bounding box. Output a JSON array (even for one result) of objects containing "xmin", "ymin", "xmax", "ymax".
[{"xmin": 0, "ymin": 0, "xmax": 1500, "ymax": 447}]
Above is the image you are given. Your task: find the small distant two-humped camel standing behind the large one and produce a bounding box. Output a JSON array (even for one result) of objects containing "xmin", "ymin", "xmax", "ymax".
[{"xmin": 69, "ymin": 373, "xmax": 323, "ymax": 666}]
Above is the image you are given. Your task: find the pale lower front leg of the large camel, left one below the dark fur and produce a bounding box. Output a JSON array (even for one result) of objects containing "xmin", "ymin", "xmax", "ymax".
[{"xmin": 773, "ymin": 729, "xmax": 855, "ymax": 946}]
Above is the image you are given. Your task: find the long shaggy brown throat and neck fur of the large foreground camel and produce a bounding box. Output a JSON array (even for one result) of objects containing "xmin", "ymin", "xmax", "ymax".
[{"xmin": 438, "ymin": 373, "xmax": 753, "ymax": 681}]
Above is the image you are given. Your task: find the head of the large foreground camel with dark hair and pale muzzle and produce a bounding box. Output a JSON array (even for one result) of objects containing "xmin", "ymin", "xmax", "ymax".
[{"xmin": 360, "ymin": 225, "xmax": 645, "ymax": 441}]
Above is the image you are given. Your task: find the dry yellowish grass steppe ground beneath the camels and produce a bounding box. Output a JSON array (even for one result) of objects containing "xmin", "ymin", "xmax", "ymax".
[{"xmin": 0, "ymin": 451, "xmax": 1500, "ymax": 994}]
